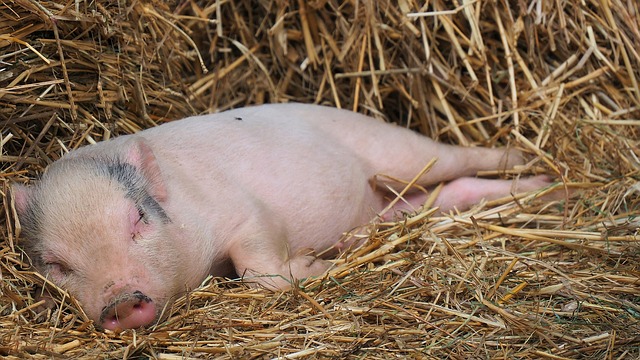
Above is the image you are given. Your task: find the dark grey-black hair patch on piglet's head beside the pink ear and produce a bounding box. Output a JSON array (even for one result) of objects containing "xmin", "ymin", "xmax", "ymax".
[{"xmin": 106, "ymin": 161, "xmax": 171, "ymax": 224}]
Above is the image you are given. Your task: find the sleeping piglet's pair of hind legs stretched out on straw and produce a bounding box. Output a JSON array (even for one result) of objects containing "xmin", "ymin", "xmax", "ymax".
[{"xmin": 365, "ymin": 127, "xmax": 551, "ymax": 215}]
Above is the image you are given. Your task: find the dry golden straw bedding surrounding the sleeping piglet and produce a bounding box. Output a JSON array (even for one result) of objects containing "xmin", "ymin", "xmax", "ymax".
[{"xmin": 0, "ymin": 0, "xmax": 640, "ymax": 359}]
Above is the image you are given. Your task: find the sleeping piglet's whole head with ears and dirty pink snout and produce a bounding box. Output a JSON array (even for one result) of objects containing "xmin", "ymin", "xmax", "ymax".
[{"xmin": 13, "ymin": 139, "xmax": 189, "ymax": 329}]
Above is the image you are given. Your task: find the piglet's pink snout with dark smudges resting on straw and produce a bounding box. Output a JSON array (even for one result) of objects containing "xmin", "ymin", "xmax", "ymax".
[{"xmin": 100, "ymin": 291, "xmax": 156, "ymax": 330}]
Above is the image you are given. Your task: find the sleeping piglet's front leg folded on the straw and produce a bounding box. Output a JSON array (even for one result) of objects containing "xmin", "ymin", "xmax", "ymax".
[{"xmin": 229, "ymin": 233, "xmax": 331, "ymax": 291}]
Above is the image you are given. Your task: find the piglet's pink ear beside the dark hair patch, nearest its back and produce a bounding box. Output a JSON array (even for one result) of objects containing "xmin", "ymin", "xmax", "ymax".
[{"xmin": 125, "ymin": 138, "xmax": 167, "ymax": 202}]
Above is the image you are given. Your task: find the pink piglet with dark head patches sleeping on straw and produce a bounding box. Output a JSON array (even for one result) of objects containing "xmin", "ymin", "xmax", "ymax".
[{"xmin": 13, "ymin": 104, "xmax": 548, "ymax": 329}]
